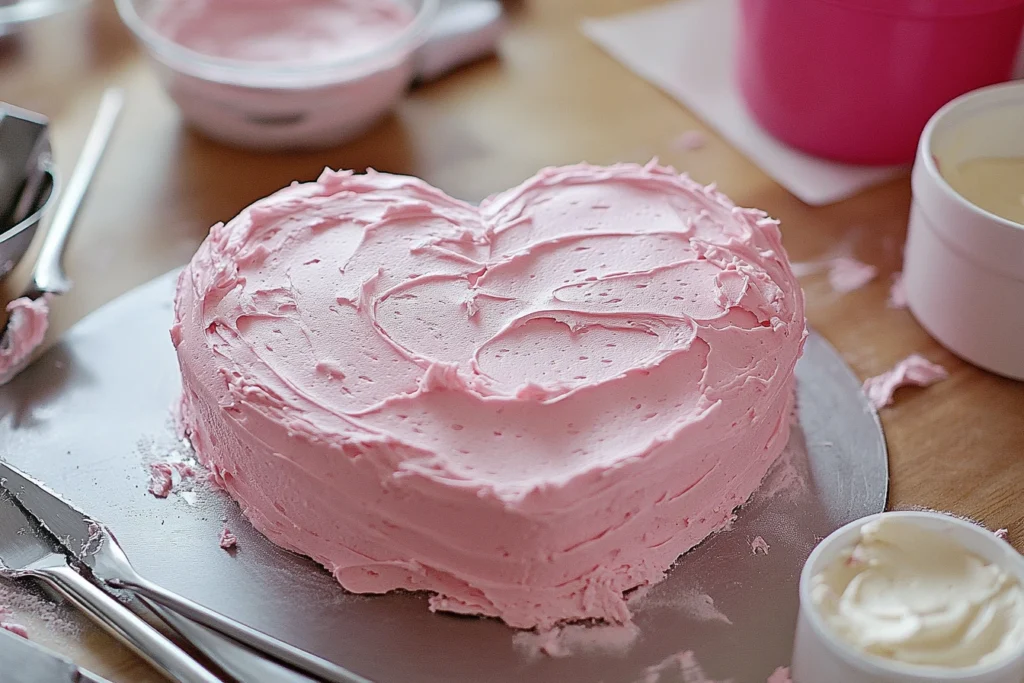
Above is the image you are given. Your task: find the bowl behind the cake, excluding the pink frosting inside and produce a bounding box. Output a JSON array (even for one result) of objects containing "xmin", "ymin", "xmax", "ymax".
[{"xmin": 116, "ymin": 0, "xmax": 437, "ymax": 150}]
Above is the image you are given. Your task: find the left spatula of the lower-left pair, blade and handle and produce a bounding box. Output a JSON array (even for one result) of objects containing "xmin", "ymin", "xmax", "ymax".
[{"xmin": 0, "ymin": 493, "xmax": 219, "ymax": 683}]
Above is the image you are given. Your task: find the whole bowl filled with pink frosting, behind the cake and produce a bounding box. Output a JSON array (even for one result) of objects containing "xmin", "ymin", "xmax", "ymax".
[{"xmin": 117, "ymin": 0, "xmax": 437, "ymax": 150}]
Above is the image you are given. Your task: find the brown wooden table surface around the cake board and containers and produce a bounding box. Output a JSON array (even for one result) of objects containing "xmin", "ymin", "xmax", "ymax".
[{"xmin": 0, "ymin": 0, "xmax": 1024, "ymax": 683}]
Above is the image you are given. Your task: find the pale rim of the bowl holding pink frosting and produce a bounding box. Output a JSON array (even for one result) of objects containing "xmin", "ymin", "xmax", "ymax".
[{"xmin": 114, "ymin": 0, "xmax": 438, "ymax": 89}]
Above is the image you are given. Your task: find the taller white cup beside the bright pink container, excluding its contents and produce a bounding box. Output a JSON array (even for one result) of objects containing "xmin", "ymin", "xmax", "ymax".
[{"xmin": 903, "ymin": 83, "xmax": 1024, "ymax": 380}]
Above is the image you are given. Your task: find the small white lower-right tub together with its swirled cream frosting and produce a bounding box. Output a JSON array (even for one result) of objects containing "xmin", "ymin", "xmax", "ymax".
[{"xmin": 793, "ymin": 512, "xmax": 1024, "ymax": 683}]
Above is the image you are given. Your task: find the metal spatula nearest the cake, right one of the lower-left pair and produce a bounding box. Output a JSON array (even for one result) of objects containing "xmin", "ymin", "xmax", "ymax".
[{"xmin": 0, "ymin": 461, "xmax": 370, "ymax": 683}]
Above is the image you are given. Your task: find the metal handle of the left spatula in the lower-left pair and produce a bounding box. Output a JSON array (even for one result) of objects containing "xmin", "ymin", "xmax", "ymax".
[{"xmin": 33, "ymin": 565, "xmax": 220, "ymax": 683}]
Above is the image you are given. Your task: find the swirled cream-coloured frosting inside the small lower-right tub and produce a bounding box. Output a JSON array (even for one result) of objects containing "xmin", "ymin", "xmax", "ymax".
[{"xmin": 811, "ymin": 519, "xmax": 1024, "ymax": 668}]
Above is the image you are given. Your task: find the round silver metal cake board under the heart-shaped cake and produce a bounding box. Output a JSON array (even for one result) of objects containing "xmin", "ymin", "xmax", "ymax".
[{"xmin": 0, "ymin": 273, "xmax": 888, "ymax": 683}]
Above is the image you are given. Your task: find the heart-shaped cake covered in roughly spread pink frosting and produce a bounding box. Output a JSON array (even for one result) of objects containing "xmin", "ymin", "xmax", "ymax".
[{"xmin": 171, "ymin": 164, "xmax": 805, "ymax": 628}]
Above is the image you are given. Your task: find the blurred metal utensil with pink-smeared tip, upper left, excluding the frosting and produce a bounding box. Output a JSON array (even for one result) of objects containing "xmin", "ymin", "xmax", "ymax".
[{"xmin": 0, "ymin": 88, "xmax": 124, "ymax": 384}]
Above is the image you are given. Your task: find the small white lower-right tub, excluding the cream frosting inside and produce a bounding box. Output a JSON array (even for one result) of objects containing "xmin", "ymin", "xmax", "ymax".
[{"xmin": 793, "ymin": 512, "xmax": 1024, "ymax": 683}]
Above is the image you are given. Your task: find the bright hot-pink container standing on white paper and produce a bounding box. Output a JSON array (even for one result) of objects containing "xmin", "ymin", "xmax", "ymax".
[{"xmin": 738, "ymin": 0, "xmax": 1024, "ymax": 164}]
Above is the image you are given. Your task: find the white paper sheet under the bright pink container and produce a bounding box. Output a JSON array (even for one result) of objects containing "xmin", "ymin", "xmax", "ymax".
[{"xmin": 582, "ymin": 0, "xmax": 903, "ymax": 206}]
